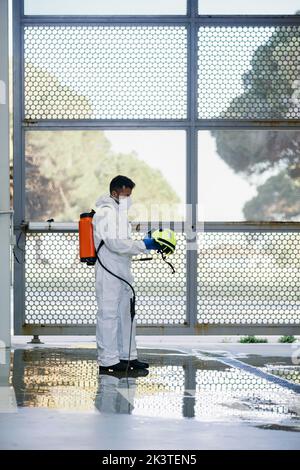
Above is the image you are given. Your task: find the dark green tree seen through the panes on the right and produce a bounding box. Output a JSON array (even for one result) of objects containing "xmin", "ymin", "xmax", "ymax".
[{"xmin": 212, "ymin": 23, "xmax": 300, "ymax": 220}]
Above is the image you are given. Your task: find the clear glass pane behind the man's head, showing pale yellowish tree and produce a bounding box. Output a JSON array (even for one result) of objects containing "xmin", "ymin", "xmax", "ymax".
[{"xmin": 25, "ymin": 130, "xmax": 186, "ymax": 222}]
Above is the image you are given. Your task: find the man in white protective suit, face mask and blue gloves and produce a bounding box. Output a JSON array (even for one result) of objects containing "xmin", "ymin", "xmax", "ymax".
[{"xmin": 93, "ymin": 175, "xmax": 160, "ymax": 373}]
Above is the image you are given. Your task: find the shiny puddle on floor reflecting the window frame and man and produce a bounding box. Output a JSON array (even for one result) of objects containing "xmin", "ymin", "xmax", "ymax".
[{"xmin": 10, "ymin": 348, "xmax": 300, "ymax": 429}]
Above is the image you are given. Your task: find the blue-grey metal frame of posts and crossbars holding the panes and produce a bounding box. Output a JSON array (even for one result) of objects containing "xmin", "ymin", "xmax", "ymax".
[{"xmin": 13, "ymin": 0, "xmax": 300, "ymax": 335}]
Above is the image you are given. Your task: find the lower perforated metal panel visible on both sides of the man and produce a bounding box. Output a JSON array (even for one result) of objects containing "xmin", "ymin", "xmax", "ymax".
[{"xmin": 25, "ymin": 233, "xmax": 186, "ymax": 325}]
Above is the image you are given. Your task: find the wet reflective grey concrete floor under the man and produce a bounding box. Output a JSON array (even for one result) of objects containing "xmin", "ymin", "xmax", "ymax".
[{"xmin": 0, "ymin": 344, "xmax": 300, "ymax": 449}]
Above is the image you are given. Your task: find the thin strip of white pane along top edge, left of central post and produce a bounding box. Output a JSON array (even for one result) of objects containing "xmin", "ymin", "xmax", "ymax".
[{"xmin": 24, "ymin": 0, "xmax": 186, "ymax": 15}]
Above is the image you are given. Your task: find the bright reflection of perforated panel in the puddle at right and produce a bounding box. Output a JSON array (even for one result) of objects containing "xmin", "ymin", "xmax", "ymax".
[{"xmin": 195, "ymin": 368, "xmax": 299, "ymax": 421}]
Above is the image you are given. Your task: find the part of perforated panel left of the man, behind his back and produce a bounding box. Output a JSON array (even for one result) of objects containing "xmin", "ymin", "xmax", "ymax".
[{"xmin": 25, "ymin": 233, "xmax": 97, "ymax": 325}]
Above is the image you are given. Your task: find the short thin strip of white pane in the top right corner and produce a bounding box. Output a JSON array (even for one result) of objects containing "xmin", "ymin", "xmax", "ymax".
[{"xmin": 198, "ymin": 0, "xmax": 300, "ymax": 15}]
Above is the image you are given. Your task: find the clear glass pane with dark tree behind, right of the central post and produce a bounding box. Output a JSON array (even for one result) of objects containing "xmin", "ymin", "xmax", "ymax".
[{"xmin": 198, "ymin": 130, "xmax": 300, "ymax": 222}]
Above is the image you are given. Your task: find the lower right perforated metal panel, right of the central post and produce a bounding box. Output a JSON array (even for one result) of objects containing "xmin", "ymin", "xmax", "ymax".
[{"xmin": 198, "ymin": 232, "xmax": 300, "ymax": 325}]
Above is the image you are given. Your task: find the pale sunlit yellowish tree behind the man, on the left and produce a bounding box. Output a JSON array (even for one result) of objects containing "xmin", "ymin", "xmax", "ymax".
[{"xmin": 25, "ymin": 63, "xmax": 180, "ymax": 221}]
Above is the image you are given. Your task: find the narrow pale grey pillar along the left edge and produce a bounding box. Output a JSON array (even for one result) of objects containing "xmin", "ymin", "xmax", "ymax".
[{"xmin": 0, "ymin": 0, "xmax": 11, "ymax": 348}]
